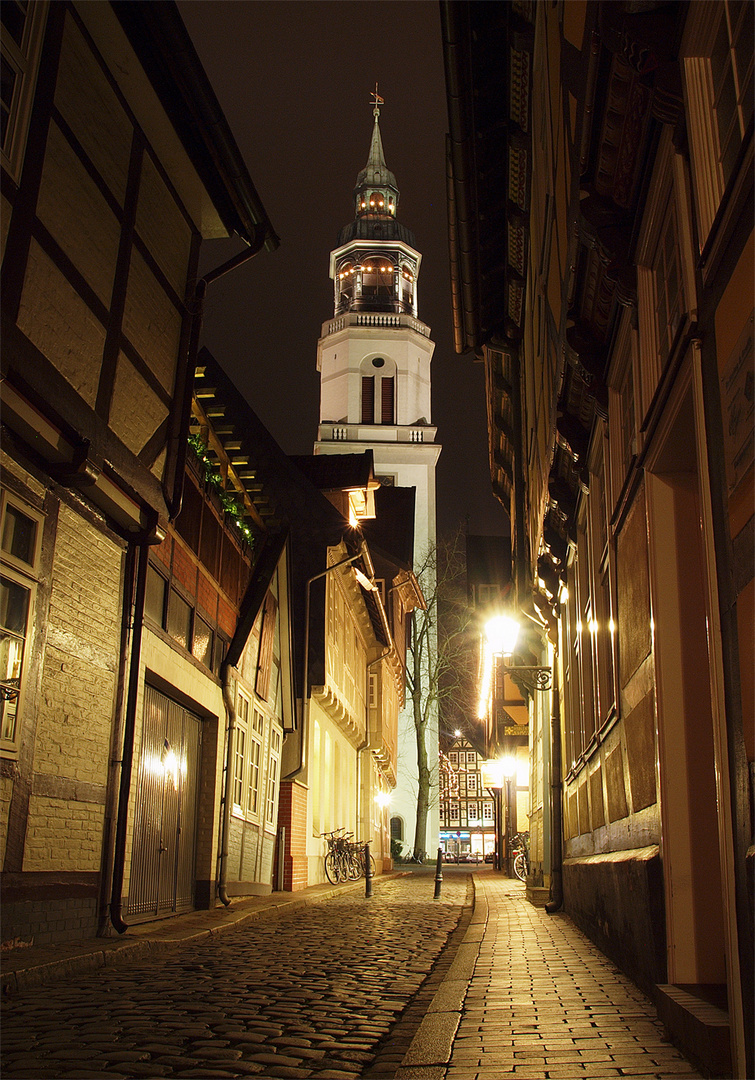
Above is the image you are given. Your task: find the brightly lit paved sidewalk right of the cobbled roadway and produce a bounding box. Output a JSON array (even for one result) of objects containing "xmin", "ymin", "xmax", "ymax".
[{"xmin": 394, "ymin": 869, "xmax": 701, "ymax": 1080}]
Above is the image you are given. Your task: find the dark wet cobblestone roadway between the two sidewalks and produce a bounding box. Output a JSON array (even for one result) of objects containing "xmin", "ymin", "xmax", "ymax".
[{"xmin": 2, "ymin": 874, "xmax": 472, "ymax": 1080}]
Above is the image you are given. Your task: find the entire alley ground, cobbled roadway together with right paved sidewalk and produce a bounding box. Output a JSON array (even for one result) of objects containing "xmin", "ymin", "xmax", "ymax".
[{"xmin": 2, "ymin": 867, "xmax": 700, "ymax": 1080}]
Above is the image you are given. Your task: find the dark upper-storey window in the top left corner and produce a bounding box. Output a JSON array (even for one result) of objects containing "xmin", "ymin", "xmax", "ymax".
[{"xmin": 0, "ymin": 0, "xmax": 48, "ymax": 180}]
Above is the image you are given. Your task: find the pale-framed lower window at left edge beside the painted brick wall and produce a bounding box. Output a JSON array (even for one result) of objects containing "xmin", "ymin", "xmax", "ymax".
[{"xmin": 0, "ymin": 492, "xmax": 42, "ymax": 750}]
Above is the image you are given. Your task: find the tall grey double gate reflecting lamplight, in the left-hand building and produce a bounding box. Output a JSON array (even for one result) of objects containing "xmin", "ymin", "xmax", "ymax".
[{"xmin": 127, "ymin": 686, "xmax": 202, "ymax": 917}]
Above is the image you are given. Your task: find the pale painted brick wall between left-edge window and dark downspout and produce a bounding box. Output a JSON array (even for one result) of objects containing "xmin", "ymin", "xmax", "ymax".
[{"xmin": 34, "ymin": 504, "xmax": 121, "ymax": 855}]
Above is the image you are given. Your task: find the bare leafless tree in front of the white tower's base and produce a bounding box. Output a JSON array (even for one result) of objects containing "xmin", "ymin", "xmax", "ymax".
[{"xmin": 406, "ymin": 528, "xmax": 473, "ymax": 858}]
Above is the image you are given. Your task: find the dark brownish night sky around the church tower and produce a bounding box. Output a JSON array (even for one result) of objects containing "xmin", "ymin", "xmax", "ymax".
[{"xmin": 178, "ymin": 0, "xmax": 508, "ymax": 534}]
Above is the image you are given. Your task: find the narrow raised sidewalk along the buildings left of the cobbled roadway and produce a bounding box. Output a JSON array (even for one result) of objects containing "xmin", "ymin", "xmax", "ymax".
[{"xmin": 0, "ymin": 872, "xmax": 375, "ymax": 997}]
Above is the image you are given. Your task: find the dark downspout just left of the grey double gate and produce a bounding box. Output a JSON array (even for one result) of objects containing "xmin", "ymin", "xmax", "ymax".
[{"xmin": 110, "ymin": 543, "xmax": 149, "ymax": 934}]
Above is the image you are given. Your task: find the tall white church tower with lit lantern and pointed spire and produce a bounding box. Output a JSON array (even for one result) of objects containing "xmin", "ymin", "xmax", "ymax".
[{"xmin": 314, "ymin": 86, "xmax": 441, "ymax": 854}]
